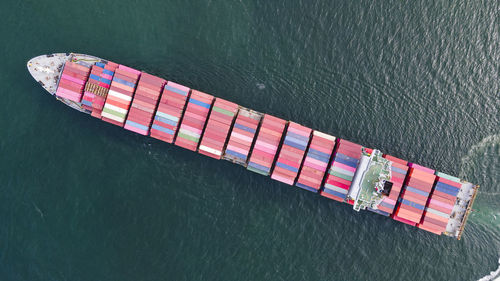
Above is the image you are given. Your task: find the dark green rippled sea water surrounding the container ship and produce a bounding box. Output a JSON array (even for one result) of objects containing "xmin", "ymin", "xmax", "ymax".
[{"xmin": 0, "ymin": 0, "xmax": 500, "ymax": 280}]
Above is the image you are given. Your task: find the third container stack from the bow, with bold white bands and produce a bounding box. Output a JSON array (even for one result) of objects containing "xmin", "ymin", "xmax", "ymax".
[{"xmin": 101, "ymin": 65, "xmax": 141, "ymax": 127}]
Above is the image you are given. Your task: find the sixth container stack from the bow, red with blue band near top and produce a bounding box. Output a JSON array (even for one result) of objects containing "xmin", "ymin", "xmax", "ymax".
[{"xmin": 175, "ymin": 90, "xmax": 214, "ymax": 151}]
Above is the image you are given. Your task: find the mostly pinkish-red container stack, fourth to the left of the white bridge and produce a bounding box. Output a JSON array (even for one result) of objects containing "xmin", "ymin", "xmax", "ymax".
[{"xmin": 247, "ymin": 114, "xmax": 286, "ymax": 176}]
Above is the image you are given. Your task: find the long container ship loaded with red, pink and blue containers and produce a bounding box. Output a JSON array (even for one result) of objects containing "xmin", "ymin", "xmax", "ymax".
[{"xmin": 27, "ymin": 53, "xmax": 479, "ymax": 239}]
